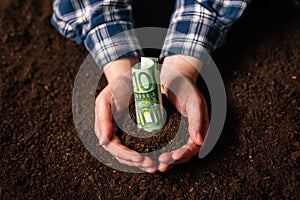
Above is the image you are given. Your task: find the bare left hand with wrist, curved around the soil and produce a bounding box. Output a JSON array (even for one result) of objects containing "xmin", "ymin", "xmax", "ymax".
[{"xmin": 95, "ymin": 57, "xmax": 156, "ymax": 173}]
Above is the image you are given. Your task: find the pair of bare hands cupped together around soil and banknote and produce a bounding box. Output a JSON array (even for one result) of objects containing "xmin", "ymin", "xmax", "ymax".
[{"xmin": 95, "ymin": 56, "xmax": 209, "ymax": 173}]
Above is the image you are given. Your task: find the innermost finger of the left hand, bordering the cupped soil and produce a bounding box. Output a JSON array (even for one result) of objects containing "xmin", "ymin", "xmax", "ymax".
[{"xmin": 103, "ymin": 135, "xmax": 144, "ymax": 162}]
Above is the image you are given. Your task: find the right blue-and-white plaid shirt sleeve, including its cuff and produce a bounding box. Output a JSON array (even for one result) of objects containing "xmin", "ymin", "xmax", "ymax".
[{"xmin": 160, "ymin": 0, "xmax": 250, "ymax": 59}]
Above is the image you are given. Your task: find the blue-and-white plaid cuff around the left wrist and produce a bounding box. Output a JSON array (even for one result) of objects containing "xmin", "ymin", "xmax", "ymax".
[{"xmin": 84, "ymin": 21, "xmax": 143, "ymax": 69}]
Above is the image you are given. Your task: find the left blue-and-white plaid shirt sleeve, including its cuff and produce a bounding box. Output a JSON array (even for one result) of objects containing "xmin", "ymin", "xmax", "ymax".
[{"xmin": 51, "ymin": 0, "xmax": 142, "ymax": 68}]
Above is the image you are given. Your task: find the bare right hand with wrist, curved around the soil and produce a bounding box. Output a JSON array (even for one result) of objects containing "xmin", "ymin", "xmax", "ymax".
[{"xmin": 158, "ymin": 55, "xmax": 209, "ymax": 172}]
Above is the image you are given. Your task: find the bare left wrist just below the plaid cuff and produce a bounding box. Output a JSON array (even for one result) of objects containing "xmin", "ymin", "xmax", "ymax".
[{"xmin": 103, "ymin": 57, "xmax": 139, "ymax": 84}]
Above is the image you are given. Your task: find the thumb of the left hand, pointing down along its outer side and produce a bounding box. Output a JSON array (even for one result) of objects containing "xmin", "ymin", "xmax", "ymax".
[{"xmin": 95, "ymin": 89, "xmax": 113, "ymax": 145}]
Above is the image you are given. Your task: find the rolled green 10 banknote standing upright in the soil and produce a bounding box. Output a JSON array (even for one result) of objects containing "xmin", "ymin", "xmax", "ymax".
[{"xmin": 132, "ymin": 57, "xmax": 164, "ymax": 132}]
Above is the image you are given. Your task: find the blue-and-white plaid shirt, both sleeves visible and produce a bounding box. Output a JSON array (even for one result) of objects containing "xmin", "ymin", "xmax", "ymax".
[{"xmin": 51, "ymin": 0, "xmax": 249, "ymax": 68}]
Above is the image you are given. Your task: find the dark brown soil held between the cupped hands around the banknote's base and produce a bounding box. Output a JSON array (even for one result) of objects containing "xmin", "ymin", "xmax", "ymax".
[{"xmin": 119, "ymin": 95, "xmax": 188, "ymax": 153}]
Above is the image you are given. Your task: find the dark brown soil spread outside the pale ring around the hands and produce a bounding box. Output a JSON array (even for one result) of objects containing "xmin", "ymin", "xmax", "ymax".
[{"xmin": 0, "ymin": 0, "xmax": 300, "ymax": 199}]
